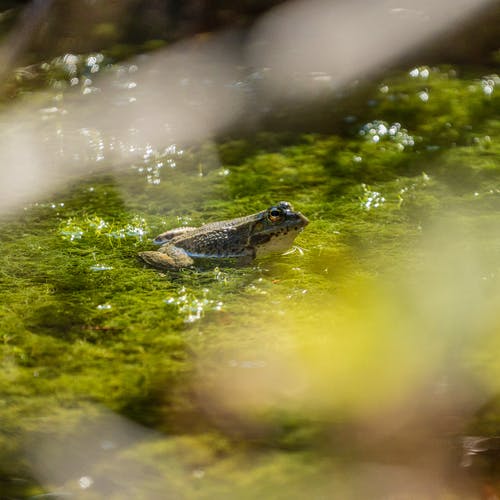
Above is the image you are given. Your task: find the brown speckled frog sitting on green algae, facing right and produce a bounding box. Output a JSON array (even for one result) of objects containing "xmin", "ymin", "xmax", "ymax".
[{"xmin": 138, "ymin": 201, "xmax": 309, "ymax": 270}]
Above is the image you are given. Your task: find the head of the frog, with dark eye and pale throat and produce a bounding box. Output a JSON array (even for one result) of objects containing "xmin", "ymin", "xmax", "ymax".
[{"xmin": 250, "ymin": 201, "xmax": 309, "ymax": 255}]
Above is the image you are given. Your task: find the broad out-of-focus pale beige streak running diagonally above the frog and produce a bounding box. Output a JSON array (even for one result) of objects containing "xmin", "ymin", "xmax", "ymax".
[{"xmin": 0, "ymin": 0, "xmax": 498, "ymax": 213}]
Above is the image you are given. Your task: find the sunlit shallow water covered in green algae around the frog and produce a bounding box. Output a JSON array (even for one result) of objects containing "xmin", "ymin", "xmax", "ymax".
[{"xmin": 0, "ymin": 59, "xmax": 500, "ymax": 498}]
